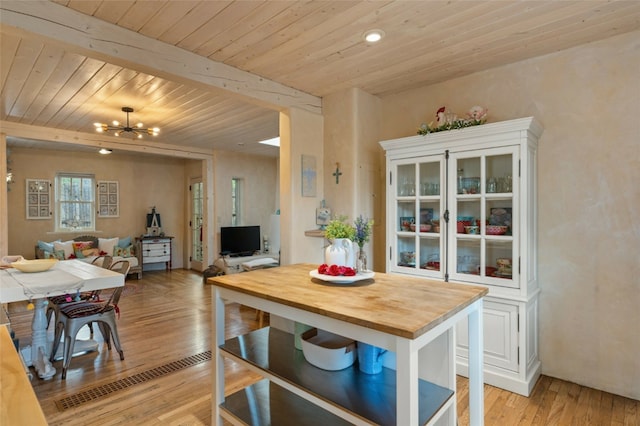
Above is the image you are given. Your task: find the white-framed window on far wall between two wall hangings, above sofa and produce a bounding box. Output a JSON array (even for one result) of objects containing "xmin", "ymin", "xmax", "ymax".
[{"xmin": 55, "ymin": 173, "xmax": 96, "ymax": 232}]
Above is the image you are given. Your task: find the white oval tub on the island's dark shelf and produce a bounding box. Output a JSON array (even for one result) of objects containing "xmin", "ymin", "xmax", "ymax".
[{"xmin": 301, "ymin": 328, "xmax": 357, "ymax": 371}]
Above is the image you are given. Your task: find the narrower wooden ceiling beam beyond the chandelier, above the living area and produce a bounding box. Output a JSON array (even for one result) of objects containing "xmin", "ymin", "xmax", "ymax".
[{"xmin": 0, "ymin": 121, "xmax": 214, "ymax": 160}]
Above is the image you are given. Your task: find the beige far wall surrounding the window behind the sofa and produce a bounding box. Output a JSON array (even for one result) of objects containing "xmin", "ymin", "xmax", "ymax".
[{"xmin": 7, "ymin": 148, "xmax": 187, "ymax": 268}]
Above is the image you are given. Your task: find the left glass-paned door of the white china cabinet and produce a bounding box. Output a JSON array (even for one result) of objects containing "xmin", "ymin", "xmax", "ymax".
[{"xmin": 390, "ymin": 156, "xmax": 444, "ymax": 277}]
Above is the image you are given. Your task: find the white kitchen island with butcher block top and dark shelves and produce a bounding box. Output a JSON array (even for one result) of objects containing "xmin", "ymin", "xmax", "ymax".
[{"xmin": 207, "ymin": 264, "xmax": 487, "ymax": 426}]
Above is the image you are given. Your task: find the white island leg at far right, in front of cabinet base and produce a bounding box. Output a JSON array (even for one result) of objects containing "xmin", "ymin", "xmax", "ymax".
[{"xmin": 468, "ymin": 299, "xmax": 484, "ymax": 426}]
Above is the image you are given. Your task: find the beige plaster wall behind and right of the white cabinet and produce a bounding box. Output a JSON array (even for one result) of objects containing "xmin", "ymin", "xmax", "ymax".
[{"xmin": 380, "ymin": 32, "xmax": 640, "ymax": 399}]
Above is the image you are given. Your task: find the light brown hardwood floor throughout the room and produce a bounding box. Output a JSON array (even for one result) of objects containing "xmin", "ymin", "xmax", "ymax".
[{"xmin": 9, "ymin": 270, "xmax": 640, "ymax": 426}]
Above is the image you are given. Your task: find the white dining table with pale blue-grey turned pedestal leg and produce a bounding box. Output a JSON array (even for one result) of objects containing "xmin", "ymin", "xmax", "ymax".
[{"xmin": 0, "ymin": 260, "xmax": 125, "ymax": 379}]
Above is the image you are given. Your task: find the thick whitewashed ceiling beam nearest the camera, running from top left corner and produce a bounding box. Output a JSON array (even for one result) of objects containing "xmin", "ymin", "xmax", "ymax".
[{"xmin": 0, "ymin": 1, "xmax": 322, "ymax": 114}]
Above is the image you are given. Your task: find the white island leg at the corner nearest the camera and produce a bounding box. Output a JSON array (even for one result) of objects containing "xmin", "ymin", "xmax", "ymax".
[{"xmin": 396, "ymin": 338, "xmax": 419, "ymax": 425}]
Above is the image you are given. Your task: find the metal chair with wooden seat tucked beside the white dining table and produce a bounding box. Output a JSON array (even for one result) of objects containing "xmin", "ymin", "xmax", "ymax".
[{"xmin": 51, "ymin": 260, "xmax": 130, "ymax": 380}]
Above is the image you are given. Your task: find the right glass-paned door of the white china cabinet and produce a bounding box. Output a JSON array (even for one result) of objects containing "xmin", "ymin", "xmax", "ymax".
[{"xmin": 449, "ymin": 147, "xmax": 519, "ymax": 287}]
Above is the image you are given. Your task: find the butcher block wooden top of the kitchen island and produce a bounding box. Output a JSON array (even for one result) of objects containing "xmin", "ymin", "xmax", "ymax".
[{"xmin": 207, "ymin": 263, "xmax": 488, "ymax": 339}]
